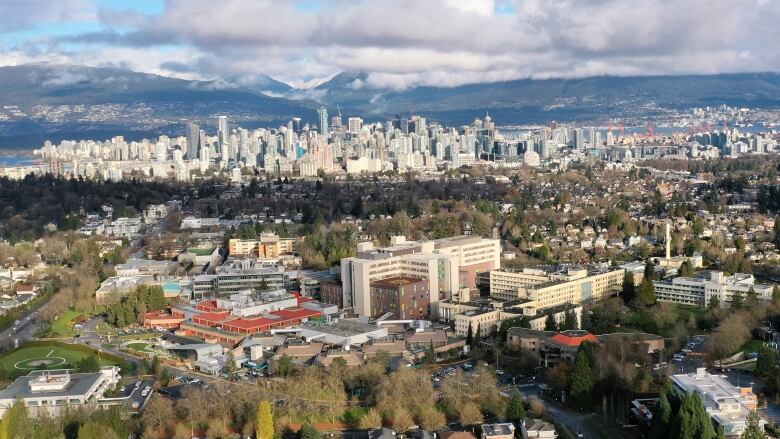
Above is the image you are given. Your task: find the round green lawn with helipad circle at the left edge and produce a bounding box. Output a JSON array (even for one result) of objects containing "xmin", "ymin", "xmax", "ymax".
[{"xmin": 0, "ymin": 342, "xmax": 123, "ymax": 379}]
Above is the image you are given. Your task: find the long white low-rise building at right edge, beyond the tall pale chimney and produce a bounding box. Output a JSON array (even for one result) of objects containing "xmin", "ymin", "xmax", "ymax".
[{"xmin": 653, "ymin": 271, "xmax": 774, "ymax": 306}]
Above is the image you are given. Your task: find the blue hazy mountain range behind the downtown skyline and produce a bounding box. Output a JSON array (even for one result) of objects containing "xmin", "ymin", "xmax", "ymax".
[{"xmin": 0, "ymin": 64, "xmax": 780, "ymax": 148}]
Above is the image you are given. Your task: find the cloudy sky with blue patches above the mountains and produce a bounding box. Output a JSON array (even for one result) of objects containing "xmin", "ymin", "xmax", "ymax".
[{"xmin": 0, "ymin": 0, "xmax": 780, "ymax": 90}]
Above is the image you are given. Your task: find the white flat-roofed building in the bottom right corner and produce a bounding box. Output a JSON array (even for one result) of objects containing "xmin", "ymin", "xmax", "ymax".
[{"xmin": 672, "ymin": 367, "xmax": 766, "ymax": 438}]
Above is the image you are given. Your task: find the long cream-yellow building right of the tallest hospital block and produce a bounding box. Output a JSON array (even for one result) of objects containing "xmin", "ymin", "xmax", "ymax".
[{"xmin": 490, "ymin": 266, "xmax": 624, "ymax": 309}]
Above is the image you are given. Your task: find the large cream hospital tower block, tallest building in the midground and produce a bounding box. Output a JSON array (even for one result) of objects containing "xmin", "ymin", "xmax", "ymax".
[{"xmin": 341, "ymin": 236, "xmax": 501, "ymax": 316}]
